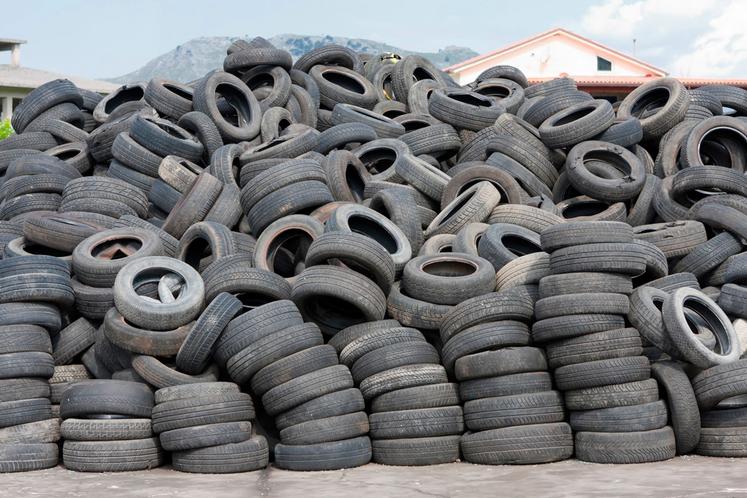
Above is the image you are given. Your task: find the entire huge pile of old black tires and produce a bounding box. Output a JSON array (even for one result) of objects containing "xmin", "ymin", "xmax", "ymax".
[{"xmin": 0, "ymin": 38, "xmax": 747, "ymax": 472}]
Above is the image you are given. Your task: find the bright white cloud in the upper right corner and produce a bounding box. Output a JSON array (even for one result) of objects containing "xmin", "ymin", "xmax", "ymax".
[{"xmin": 579, "ymin": 0, "xmax": 747, "ymax": 77}]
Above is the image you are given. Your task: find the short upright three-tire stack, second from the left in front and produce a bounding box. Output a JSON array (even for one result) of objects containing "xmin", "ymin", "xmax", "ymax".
[{"xmin": 60, "ymin": 380, "xmax": 164, "ymax": 472}]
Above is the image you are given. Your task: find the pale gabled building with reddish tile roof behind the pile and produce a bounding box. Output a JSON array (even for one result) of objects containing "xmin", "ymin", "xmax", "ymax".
[{"xmin": 446, "ymin": 28, "xmax": 747, "ymax": 100}]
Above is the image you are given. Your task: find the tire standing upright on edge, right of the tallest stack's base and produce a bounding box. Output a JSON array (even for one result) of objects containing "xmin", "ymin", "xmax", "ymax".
[{"xmin": 651, "ymin": 361, "xmax": 705, "ymax": 455}]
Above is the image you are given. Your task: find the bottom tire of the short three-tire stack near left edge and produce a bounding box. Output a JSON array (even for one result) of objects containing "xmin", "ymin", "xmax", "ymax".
[{"xmin": 62, "ymin": 437, "xmax": 164, "ymax": 472}]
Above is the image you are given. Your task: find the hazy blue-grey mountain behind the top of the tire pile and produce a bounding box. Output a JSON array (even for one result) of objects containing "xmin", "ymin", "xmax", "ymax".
[{"xmin": 107, "ymin": 34, "xmax": 477, "ymax": 83}]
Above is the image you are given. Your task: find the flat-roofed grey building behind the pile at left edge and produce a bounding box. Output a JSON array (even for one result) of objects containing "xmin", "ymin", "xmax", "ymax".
[{"xmin": 0, "ymin": 38, "xmax": 119, "ymax": 119}]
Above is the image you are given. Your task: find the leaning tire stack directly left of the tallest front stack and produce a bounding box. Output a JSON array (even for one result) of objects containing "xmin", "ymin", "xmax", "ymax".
[{"xmin": 441, "ymin": 285, "xmax": 573, "ymax": 465}]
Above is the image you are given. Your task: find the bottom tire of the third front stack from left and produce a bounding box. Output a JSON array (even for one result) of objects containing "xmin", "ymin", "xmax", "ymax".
[{"xmin": 171, "ymin": 435, "xmax": 269, "ymax": 474}]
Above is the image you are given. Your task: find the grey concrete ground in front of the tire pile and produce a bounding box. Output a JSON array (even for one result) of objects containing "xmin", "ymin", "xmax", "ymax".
[{"xmin": 0, "ymin": 456, "xmax": 747, "ymax": 498}]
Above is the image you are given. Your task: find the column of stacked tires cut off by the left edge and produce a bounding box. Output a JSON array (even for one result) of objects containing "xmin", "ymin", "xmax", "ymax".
[{"xmin": 0, "ymin": 256, "xmax": 73, "ymax": 472}]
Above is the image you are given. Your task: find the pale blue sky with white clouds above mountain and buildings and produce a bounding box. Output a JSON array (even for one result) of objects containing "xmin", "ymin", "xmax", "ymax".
[{"xmin": 0, "ymin": 0, "xmax": 747, "ymax": 78}]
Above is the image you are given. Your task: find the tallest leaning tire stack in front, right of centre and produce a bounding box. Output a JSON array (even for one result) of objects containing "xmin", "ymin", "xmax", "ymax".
[{"xmin": 532, "ymin": 222, "xmax": 675, "ymax": 463}]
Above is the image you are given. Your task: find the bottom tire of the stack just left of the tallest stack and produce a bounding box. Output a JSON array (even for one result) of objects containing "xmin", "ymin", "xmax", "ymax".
[{"xmin": 461, "ymin": 423, "xmax": 573, "ymax": 465}]
